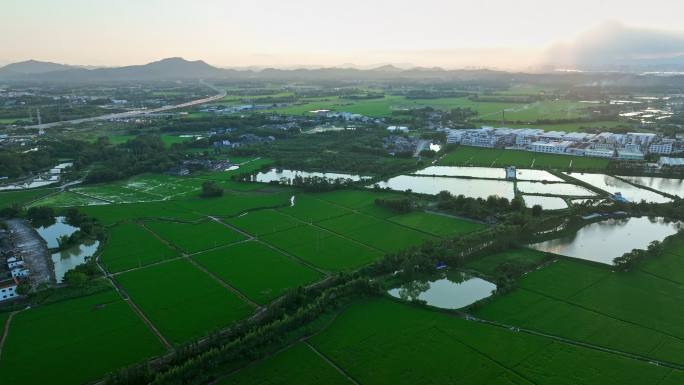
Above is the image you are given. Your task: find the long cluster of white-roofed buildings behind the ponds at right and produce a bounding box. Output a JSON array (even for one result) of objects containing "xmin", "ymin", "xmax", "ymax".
[{"xmin": 446, "ymin": 127, "xmax": 684, "ymax": 161}]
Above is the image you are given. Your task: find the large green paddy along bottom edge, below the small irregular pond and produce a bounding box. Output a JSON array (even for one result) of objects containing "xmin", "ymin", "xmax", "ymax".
[{"xmin": 311, "ymin": 299, "xmax": 670, "ymax": 385}]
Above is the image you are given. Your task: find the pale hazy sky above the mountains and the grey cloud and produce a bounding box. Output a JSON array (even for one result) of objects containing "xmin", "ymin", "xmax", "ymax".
[{"xmin": 0, "ymin": 0, "xmax": 684, "ymax": 67}]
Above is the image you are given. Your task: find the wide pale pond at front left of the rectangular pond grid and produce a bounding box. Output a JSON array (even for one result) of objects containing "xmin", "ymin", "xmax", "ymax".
[{"xmin": 369, "ymin": 175, "xmax": 514, "ymax": 199}]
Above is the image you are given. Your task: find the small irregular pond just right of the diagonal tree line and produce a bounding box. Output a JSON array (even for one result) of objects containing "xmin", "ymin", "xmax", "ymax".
[{"xmin": 388, "ymin": 272, "xmax": 496, "ymax": 309}]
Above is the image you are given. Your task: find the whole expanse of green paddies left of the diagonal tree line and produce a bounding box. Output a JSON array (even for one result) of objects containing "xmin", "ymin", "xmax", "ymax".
[{"xmin": 0, "ymin": 175, "xmax": 492, "ymax": 384}]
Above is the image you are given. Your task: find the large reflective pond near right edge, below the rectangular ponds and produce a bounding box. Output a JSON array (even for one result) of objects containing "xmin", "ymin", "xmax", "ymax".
[{"xmin": 531, "ymin": 217, "xmax": 682, "ymax": 264}]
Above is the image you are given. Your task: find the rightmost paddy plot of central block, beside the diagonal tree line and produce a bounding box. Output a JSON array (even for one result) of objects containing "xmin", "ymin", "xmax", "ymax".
[{"xmin": 389, "ymin": 211, "xmax": 487, "ymax": 237}]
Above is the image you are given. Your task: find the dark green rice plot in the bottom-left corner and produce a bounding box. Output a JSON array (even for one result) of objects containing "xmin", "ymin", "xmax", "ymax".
[{"xmin": 0, "ymin": 290, "xmax": 164, "ymax": 385}]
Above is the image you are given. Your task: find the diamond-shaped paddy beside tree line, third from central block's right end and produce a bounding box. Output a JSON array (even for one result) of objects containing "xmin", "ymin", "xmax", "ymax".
[{"xmin": 262, "ymin": 225, "xmax": 383, "ymax": 271}]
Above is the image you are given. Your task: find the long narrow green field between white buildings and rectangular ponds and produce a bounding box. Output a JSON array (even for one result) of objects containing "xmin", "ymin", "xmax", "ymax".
[{"xmin": 439, "ymin": 146, "xmax": 609, "ymax": 170}]
